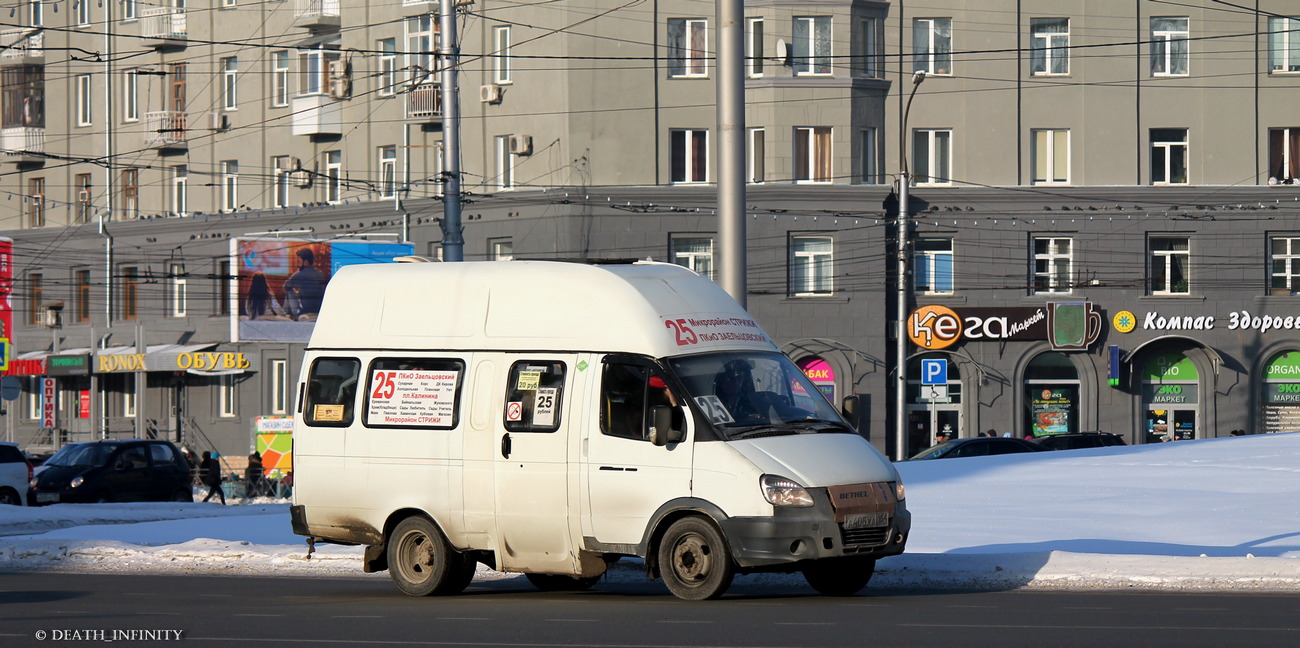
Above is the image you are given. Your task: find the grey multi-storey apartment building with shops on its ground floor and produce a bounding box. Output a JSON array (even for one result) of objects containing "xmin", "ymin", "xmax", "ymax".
[{"xmin": 0, "ymin": 0, "xmax": 1300, "ymax": 455}]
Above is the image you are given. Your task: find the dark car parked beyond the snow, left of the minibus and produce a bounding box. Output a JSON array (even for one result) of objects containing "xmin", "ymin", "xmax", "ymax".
[{"xmin": 27, "ymin": 440, "xmax": 194, "ymax": 505}]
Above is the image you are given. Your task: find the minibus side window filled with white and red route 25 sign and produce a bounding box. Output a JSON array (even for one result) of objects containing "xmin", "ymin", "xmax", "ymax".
[{"xmin": 364, "ymin": 358, "xmax": 465, "ymax": 429}]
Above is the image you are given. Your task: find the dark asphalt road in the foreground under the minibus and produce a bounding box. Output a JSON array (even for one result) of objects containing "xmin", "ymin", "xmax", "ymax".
[{"xmin": 0, "ymin": 574, "xmax": 1300, "ymax": 648}]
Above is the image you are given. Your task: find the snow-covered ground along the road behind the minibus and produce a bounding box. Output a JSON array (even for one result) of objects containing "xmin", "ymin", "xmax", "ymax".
[{"xmin": 0, "ymin": 433, "xmax": 1300, "ymax": 591}]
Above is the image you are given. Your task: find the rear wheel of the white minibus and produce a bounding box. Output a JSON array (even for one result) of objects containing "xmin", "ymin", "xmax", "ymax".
[{"xmin": 387, "ymin": 515, "xmax": 475, "ymax": 596}]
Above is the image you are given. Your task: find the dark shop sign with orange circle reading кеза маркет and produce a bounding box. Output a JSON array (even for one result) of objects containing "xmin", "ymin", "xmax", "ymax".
[{"xmin": 907, "ymin": 302, "xmax": 1104, "ymax": 351}]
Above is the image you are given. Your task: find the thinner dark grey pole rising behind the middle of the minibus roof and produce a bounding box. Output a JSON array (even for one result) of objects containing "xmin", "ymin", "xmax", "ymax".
[{"xmin": 437, "ymin": 1, "xmax": 465, "ymax": 262}]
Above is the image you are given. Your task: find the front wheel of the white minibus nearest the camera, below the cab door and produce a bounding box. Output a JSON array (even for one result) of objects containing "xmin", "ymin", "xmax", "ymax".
[{"xmin": 659, "ymin": 518, "xmax": 736, "ymax": 601}]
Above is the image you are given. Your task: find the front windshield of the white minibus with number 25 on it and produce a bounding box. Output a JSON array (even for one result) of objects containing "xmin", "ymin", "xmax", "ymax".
[{"xmin": 668, "ymin": 351, "xmax": 853, "ymax": 440}]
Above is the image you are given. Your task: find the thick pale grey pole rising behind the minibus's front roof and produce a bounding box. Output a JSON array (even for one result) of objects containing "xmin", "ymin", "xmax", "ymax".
[{"xmin": 718, "ymin": 0, "xmax": 748, "ymax": 300}]
